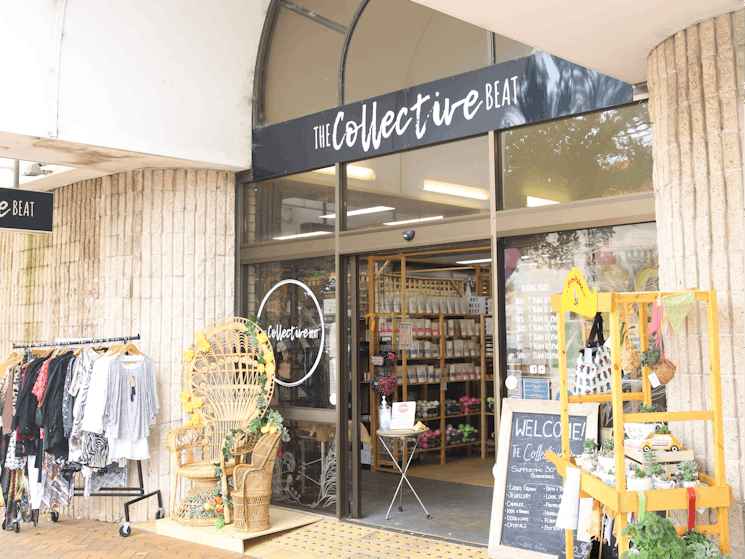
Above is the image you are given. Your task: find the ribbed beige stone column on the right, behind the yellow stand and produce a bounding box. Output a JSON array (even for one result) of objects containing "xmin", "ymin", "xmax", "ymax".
[{"xmin": 647, "ymin": 9, "xmax": 745, "ymax": 557}]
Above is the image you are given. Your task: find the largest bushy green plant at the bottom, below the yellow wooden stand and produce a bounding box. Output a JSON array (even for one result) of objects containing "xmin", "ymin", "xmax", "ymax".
[{"xmin": 621, "ymin": 513, "xmax": 686, "ymax": 559}]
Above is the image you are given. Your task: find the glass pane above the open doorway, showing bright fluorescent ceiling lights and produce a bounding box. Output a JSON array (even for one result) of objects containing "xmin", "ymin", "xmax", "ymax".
[{"xmin": 332, "ymin": 136, "xmax": 489, "ymax": 230}]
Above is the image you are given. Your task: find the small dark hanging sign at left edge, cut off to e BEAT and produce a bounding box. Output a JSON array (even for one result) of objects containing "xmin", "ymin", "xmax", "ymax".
[{"xmin": 0, "ymin": 188, "xmax": 54, "ymax": 233}]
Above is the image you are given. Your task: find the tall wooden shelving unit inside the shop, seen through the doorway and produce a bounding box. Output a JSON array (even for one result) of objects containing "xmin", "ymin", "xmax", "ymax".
[{"xmin": 364, "ymin": 255, "xmax": 494, "ymax": 472}]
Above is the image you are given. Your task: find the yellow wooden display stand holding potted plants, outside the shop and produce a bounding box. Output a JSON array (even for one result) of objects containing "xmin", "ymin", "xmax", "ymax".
[{"xmin": 546, "ymin": 289, "xmax": 732, "ymax": 559}]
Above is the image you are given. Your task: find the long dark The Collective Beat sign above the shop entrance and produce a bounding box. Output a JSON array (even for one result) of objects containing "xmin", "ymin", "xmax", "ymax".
[{"xmin": 253, "ymin": 52, "xmax": 632, "ymax": 178}]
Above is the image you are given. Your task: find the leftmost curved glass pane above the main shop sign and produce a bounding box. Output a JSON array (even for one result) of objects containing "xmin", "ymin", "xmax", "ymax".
[{"xmin": 254, "ymin": 0, "xmax": 357, "ymax": 126}]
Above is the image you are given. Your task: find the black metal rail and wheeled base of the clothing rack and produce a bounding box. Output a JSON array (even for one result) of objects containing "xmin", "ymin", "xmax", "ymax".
[{"xmin": 4, "ymin": 334, "xmax": 165, "ymax": 538}]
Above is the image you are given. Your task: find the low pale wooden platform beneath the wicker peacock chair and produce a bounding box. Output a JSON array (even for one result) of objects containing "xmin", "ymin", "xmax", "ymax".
[{"xmin": 153, "ymin": 507, "xmax": 323, "ymax": 553}]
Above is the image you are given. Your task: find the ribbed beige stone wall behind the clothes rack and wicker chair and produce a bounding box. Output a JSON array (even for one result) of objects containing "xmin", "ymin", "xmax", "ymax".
[{"xmin": 0, "ymin": 169, "xmax": 235, "ymax": 521}]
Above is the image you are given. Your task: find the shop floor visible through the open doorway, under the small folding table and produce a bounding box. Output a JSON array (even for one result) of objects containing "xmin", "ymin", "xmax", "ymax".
[{"xmin": 360, "ymin": 470, "xmax": 493, "ymax": 544}]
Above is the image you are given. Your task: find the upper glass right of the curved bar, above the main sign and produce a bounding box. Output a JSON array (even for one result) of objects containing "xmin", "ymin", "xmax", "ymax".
[{"xmin": 344, "ymin": 0, "xmax": 533, "ymax": 103}]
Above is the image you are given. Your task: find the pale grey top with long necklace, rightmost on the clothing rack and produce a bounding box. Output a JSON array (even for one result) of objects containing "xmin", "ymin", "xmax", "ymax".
[{"xmin": 104, "ymin": 356, "xmax": 159, "ymax": 461}]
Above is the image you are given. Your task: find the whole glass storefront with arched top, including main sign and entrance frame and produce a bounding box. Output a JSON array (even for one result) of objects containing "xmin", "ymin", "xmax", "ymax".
[{"xmin": 238, "ymin": 0, "xmax": 664, "ymax": 540}]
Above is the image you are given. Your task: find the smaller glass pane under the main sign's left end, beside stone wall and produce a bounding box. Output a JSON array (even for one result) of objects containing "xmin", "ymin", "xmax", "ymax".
[{"xmin": 243, "ymin": 172, "xmax": 334, "ymax": 244}]
